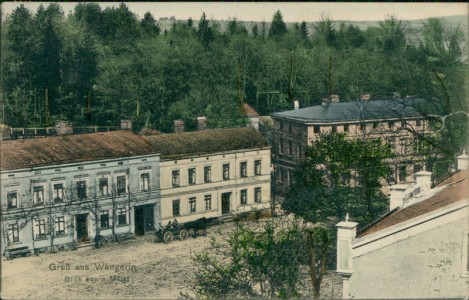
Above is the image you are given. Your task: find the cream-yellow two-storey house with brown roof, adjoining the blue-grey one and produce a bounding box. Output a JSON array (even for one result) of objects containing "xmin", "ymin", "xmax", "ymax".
[{"xmin": 145, "ymin": 128, "xmax": 271, "ymax": 225}]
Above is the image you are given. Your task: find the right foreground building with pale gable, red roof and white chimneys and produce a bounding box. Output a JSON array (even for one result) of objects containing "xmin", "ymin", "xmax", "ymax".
[{"xmin": 337, "ymin": 155, "xmax": 469, "ymax": 299}]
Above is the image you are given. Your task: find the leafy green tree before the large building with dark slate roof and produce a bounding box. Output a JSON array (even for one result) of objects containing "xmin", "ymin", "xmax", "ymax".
[{"xmin": 282, "ymin": 134, "xmax": 393, "ymax": 223}]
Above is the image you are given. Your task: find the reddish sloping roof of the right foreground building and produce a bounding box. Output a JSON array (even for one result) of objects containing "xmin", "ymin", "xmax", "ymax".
[{"xmin": 357, "ymin": 170, "xmax": 469, "ymax": 238}]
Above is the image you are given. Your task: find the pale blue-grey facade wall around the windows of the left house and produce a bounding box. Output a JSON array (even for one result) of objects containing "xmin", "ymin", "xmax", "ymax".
[{"xmin": 0, "ymin": 154, "xmax": 159, "ymax": 253}]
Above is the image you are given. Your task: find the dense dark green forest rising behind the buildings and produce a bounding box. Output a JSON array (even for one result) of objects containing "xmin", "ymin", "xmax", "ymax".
[{"xmin": 1, "ymin": 3, "xmax": 467, "ymax": 141}]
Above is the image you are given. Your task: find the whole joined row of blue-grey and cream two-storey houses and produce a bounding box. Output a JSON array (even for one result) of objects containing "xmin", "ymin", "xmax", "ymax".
[{"xmin": 0, "ymin": 128, "xmax": 271, "ymax": 254}]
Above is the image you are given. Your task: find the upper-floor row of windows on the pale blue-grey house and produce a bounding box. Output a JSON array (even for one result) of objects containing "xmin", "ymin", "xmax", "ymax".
[{"xmin": 7, "ymin": 173, "xmax": 150, "ymax": 209}]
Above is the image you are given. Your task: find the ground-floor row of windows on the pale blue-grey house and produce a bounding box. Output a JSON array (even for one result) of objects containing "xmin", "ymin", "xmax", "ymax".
[{"xmin": 8, "ymin": 207, "xmax": 128, "ymax": 242}]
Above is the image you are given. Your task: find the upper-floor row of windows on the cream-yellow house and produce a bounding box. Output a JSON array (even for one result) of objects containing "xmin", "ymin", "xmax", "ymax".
[{"xmin": 172, "ymin": 160, "xmax": 261, "ymax": 187}]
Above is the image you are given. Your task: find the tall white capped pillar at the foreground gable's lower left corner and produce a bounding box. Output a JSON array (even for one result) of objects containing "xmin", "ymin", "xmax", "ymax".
[{"xmin": 335, "ymin": 214, "xmax": 358, "ymax": 299}]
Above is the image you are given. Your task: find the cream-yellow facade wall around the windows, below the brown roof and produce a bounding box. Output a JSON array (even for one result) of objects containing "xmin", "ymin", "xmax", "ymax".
[{"xmin": 161, "ymin": 148, "xmax": 271, "ymax": 225}]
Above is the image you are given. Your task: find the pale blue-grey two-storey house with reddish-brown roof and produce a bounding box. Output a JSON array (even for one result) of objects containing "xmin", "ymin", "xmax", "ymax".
[{"xmin": 0, "ymin": 131, "xmax": 160, "ymax": 253}]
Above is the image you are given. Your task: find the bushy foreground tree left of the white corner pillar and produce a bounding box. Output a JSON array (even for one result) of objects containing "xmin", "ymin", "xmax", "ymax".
[{"xmin": 186, "ymin": 217, "xmax": 330, "ymax": 299}]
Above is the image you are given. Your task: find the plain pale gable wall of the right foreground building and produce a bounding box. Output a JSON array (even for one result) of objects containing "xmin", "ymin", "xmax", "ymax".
[{"xmin": 350, "ymin": 217, "xmax": 469, "ymax": 299}]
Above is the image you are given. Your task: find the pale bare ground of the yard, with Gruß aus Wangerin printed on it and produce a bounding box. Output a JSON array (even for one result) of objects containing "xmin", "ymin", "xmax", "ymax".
[{"xmin": 1, "ymin": 223, "xmax": 341, "ymax": 299}]
